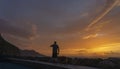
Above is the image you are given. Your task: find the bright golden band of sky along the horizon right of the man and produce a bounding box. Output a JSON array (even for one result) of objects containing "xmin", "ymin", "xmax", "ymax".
[{"xmin": 61, "ymin": 43, "xmax": 120, "ymax": 57}]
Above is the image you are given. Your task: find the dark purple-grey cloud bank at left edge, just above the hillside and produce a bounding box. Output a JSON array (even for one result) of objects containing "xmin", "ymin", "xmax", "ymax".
[{"xmin": 0, "ymin": 19, "xmax": 37, "ymax": 38}]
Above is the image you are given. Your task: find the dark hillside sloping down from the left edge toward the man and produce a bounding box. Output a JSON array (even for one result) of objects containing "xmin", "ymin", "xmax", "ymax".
[{"xmin": 0, "ymin": 34, "xmax": 45, "ymax": 57}]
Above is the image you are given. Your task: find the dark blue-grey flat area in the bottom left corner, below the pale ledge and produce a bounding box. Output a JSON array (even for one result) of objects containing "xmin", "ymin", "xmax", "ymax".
[{"xmin": 0, "ymin": 62, "xmax": 31, "ymax": 69}]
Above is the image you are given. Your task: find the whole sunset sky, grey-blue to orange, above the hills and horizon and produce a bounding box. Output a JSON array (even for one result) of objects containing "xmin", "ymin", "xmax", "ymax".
[{"xmin": 0, "ymin": 0, "xmax": 120, "ymax": 57}]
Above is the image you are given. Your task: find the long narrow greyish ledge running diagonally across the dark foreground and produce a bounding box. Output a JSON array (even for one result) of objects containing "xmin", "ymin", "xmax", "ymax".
[{"xmin": 7, "ymin": 58, "xmax": 99, "ymax": 69}]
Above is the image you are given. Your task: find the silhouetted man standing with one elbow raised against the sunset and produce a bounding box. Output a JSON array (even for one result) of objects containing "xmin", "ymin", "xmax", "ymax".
[{"xmin": 50, "ymin": 41, "xmax": 59, "ymax": 58}]
